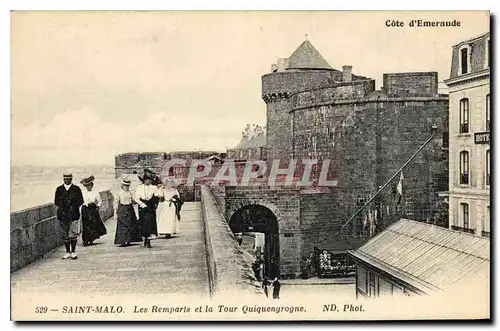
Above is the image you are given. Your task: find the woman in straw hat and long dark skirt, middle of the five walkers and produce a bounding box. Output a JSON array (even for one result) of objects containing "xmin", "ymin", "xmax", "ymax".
[{"xmin": 114, "ymin": 178, "xmax": 141, "ymax": 247}]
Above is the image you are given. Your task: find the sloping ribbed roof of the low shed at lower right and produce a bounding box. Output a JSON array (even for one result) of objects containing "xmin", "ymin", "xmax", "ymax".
[{"xmin": 358, "ymin": 219, "xmax": 490, "ymax": 294}]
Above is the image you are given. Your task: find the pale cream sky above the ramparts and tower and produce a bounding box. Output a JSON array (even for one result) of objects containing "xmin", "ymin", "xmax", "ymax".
[{"xmin": 11, "ymin": 12, "xmax": 489, "ymax": 166}]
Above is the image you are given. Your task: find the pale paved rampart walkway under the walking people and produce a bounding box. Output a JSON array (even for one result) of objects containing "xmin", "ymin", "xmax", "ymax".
[{"xmin": 11, "ymin": 202, "xmax": 209, "ymax": 297}]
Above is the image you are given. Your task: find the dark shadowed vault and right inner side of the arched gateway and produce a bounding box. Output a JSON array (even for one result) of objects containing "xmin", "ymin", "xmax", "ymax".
[{"xmin": 229, "ymin": 204, "xmax": 280, "ymax": 278}]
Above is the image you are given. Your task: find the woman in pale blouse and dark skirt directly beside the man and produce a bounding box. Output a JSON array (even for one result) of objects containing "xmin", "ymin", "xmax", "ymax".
[{"xmin": 80, "ymin": 176, "xmax": 107, "ymax": 246}]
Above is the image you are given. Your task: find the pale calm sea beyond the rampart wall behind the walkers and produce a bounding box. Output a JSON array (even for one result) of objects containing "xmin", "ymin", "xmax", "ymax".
[{"xmin": 10, "ymin": 174, "xmax": 119, "ymax": 212}]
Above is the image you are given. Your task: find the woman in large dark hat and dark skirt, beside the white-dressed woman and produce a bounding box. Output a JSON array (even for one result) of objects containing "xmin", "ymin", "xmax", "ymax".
[{"xmin": 135, "ymin": 169, "xmax": 159, "ymax": 248}]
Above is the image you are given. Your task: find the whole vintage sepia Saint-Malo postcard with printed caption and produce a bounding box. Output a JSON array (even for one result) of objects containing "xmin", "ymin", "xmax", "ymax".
[{"xmin": 10, "ymin": 10, "xmax": 492, "ymax": 321}]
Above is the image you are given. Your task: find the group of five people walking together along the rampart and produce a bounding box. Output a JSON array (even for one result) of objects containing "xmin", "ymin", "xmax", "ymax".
[{"xmin": 54, "ymin": 169, "xmax": 183, "ymax": 259}]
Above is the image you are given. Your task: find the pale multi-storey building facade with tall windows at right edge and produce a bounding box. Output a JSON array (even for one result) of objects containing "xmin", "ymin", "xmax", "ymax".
[{"xmin": 445, "ymin": 33, "xmax": 491, "ymax": 237}]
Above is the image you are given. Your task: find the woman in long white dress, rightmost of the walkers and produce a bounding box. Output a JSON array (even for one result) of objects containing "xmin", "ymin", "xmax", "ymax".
[{"xmin": 156, "ymin": 178, "xmax": 180, "ymax": 238}]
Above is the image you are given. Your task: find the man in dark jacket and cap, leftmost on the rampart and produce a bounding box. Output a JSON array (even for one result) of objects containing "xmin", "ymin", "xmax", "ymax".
[{"xmin": 54, "ymin": 174, "xmax": 83, "ymax": 260}]
